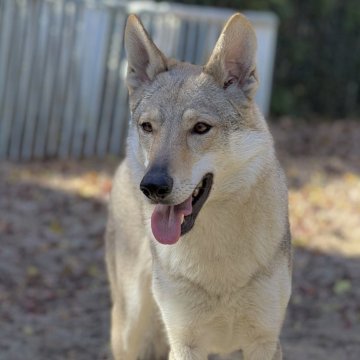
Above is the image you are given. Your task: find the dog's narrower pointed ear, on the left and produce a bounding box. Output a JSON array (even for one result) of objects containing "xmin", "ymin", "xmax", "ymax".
[{"xmin": 124, "ymin": 15, "xmax": 167, "ymax": 93}]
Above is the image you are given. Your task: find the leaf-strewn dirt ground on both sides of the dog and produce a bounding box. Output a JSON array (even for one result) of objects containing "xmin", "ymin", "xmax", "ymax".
[{"xmin": 0, "ymin": 119, "xmax": 360, "ymax": 360}]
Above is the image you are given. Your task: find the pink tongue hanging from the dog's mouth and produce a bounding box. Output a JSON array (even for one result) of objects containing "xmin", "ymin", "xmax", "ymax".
[{"xmin": 151, "ymin": 196, "xmax": 192, "ymax": 245}]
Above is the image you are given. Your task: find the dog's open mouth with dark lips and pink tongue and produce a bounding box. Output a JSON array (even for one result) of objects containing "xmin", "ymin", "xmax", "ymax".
[{"xmin": 151, "ymin": 174, "xmax": 213, "ymax": 244}]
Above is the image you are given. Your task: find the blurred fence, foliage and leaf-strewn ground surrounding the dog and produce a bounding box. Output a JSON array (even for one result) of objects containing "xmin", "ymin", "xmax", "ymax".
[{"xmin": 0, "ymin": 0, "xmax": 360, "ymax": 360}]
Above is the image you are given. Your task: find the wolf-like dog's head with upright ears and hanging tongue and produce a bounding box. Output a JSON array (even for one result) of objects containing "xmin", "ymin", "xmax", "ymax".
[{"xmin": 125, "ymin": 14, "xmax": 271, "ymax": 243}]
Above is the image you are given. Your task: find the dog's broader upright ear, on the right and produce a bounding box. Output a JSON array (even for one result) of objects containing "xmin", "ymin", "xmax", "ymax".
[{"xmin": 204, "ymin": 13, "xmax": 258, "ymax": 98}]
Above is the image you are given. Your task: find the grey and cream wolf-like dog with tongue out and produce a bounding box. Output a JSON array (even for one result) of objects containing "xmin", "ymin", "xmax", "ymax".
[{"xmin": 106, "ymin": 13, "xmax": 291, "ymax": 360}]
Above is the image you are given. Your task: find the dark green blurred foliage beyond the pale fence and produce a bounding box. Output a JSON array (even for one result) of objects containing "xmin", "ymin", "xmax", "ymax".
[{"xmin": 172, "ymin": 0, "xmax": 360, "ymax": 118}]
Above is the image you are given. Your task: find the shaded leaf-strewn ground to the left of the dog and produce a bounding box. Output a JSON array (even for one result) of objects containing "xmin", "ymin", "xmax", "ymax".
[{"xmin": 0, "ymin": 180, "xmax": 109, "ymax": 360}]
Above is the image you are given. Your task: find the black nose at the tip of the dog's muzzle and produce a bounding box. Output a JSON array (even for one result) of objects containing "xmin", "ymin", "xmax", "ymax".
[{"xmin": 140, "ymin": 170, "xmax": 174, "ymax": 201}]
